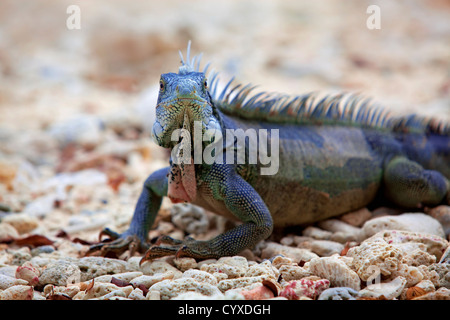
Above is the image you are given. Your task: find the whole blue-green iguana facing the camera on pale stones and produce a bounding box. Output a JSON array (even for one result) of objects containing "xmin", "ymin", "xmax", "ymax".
[{"xmin": 90, "ymin": 43, "xmax": 450, "ymax": 262}]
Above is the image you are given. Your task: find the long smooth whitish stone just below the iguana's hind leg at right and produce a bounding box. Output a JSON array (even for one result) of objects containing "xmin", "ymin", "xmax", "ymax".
[{"xmin": 362, "ymin": 213, "xmax": 445, "ymax": 238}]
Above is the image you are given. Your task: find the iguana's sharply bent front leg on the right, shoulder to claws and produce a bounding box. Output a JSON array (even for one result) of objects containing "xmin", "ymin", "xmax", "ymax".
[{"xmin": 141, "ymin": 165, "xmax": 273, "ymax": 263}]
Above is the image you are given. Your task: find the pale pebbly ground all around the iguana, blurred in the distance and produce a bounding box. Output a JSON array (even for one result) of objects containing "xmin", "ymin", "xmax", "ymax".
[{"xmin": 0, "ymin": 0, "xmax": 450, "ymax": 300}]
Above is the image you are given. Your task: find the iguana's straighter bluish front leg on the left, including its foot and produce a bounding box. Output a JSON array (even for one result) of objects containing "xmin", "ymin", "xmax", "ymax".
[{"xmin": 87, "ymin": 167, "xmax": 170, "ymax": 255}]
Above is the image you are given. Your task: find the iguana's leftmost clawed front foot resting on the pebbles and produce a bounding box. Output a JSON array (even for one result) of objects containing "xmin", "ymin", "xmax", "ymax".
[{"xmin": 86, "ymin": 228, "xmax": 148, "ymax": 257}]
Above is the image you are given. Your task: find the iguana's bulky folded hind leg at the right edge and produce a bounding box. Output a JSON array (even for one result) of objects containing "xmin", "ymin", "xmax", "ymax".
[{"xmin": 383, "ymin": 157, "xmax": 450, "ymax": 208}]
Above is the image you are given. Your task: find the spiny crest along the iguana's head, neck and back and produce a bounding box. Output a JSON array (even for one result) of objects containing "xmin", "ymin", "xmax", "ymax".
[{"xmin": 179, "ymin": 41, "xmax": 450, "ymax": 135}]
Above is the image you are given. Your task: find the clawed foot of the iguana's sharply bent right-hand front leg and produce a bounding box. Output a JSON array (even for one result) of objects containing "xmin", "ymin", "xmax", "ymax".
[{"xmin": 139, "ymin": 236, "xmax": 220, "ymax": 265}]
